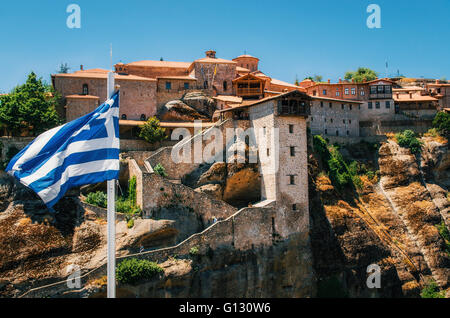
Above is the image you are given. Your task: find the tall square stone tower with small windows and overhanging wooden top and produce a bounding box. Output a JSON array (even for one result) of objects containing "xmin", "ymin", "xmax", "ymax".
[{"xmin": 248, "ymin": 91, "xmax": 311, "ymax": 237}]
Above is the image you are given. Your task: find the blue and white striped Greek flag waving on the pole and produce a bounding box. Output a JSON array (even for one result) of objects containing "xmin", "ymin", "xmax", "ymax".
[{"xmin": 6, "ymin": 91, "xmax": 120, "ymax": 208}]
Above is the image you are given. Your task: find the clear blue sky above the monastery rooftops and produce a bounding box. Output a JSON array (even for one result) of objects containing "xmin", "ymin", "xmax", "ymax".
[{"xmin": 0, "ymin": 0, "xmax": 450, "ymax": 92}]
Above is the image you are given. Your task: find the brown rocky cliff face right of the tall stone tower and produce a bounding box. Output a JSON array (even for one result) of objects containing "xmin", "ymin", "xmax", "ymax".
[{"xmin": 309, "ymin": 141, "xmax": 450, "ymax": 297}]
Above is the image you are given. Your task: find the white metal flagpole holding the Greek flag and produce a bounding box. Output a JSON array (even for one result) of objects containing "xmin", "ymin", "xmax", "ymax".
[{"xmin": 106, "ymin": 67, "xmax": 116, "ymax": 298}]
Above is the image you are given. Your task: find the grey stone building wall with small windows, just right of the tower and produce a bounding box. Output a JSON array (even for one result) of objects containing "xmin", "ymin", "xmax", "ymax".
[{"xmin": 308, "ymin": 99, "xmax": 360, "ymax": 137}]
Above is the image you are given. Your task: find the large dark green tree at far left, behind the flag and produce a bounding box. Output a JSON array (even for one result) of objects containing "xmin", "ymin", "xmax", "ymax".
[{"xmin": 0, "ymin": 72, "xmax": 61, "ymax": 135}]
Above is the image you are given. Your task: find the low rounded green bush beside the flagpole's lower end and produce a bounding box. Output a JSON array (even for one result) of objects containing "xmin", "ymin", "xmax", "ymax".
[{"xmin": 116, "ymin": 258, "xmax": 164, "ymax": 284}]
